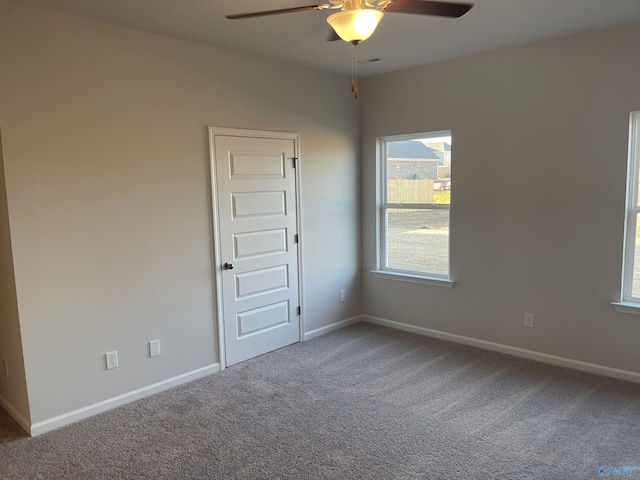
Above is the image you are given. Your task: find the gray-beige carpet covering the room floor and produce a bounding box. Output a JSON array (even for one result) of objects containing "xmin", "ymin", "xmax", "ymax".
[{"xmin": 0, "ymin": 324, "xmax": 640, "ymax": 480}]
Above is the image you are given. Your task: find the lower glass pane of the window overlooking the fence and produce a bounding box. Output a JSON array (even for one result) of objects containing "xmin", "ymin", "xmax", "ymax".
[{"xmin": 387, "ymin": 208, "xmax": 449, "ymax": 275}]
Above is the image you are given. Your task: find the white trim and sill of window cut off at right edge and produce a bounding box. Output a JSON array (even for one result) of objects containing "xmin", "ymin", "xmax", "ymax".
[{"xmin": 611, "ymin": 112, "xmax": 640, "ymax": 315}]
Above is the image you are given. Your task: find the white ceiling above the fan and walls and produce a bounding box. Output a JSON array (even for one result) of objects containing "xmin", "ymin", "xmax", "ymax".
[{"xmin": 0, "ymin": 0, "xmax": 640, "ymax": 76}]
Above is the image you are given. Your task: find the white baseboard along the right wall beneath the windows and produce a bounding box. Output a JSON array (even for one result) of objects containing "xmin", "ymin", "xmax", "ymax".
[{"xmin": 362, "ymin": 315, "xmax": 640, "ymax": 383}]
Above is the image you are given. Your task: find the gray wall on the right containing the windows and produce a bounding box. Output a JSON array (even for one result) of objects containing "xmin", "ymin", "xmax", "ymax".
[{"xmin": 360, "ymin": 24, "xmax": 640, "ymax": 372}]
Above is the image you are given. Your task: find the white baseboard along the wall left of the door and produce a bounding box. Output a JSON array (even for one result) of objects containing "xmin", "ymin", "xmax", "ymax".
[{"xmin": 26, "ymin": 363, "xmax": 220, "ymax": 437}]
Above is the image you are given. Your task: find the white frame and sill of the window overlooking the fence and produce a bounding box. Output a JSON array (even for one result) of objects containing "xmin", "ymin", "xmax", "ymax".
[{"xmin": 372, "ymin": 130, "xmax": 454, "ymax": 288}]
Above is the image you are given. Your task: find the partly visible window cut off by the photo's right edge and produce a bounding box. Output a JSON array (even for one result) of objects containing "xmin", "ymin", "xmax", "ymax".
[{"xmin": 614, "ymin": 112, "xmax": 640, "ymax": 314}]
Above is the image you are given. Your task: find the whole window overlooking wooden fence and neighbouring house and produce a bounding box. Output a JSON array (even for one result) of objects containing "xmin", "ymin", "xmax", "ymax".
[{"xmin": 374, "ymin": 131, "xmax": 453, "ymax": 286}]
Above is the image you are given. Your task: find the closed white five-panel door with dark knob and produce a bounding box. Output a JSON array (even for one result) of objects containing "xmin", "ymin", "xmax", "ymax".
[{"xmin": 211, "ymin": 129, "xmax": 300, "ymax": 366}]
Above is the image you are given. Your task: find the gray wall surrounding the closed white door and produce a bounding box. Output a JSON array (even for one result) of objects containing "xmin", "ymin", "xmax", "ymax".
[{"xmin": 0, "ymin": 5, "xmax": 361, "ymax": 423}]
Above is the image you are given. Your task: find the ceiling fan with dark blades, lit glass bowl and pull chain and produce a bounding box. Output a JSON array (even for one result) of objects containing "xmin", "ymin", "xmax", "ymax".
[{"xmin": 226, "ymin": 0, "xmax": 473, "ymax": 98}]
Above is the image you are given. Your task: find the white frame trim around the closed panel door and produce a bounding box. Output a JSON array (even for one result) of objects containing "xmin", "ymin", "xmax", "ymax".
[{"xmin": 209, "ymin": 127, "xmax": 305, "ymax": 370}]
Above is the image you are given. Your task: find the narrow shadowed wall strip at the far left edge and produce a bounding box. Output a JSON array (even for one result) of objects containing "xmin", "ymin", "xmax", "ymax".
[{"xmin": 0, "ymin": 127, "xmax": 30, "ymax": 427}]
